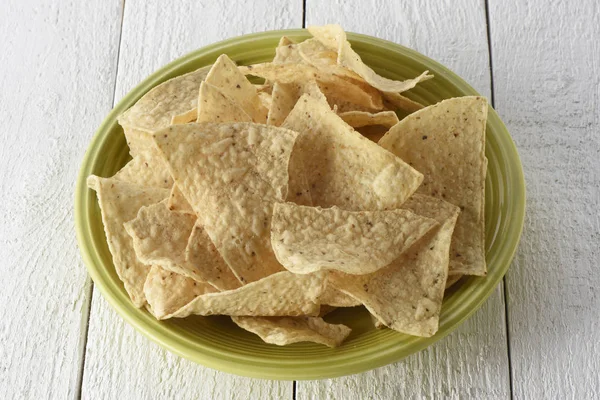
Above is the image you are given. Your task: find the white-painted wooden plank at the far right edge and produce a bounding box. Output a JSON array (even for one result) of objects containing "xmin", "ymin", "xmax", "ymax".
[{"xmin": 490, "ymin": 0, "xmax": 600, "ymax": 399}]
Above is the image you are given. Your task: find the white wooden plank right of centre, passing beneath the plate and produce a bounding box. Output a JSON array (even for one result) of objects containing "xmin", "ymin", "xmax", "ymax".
[{"xmin": 297, "ymin": 0, "xmax": 510, "ymax": 399}]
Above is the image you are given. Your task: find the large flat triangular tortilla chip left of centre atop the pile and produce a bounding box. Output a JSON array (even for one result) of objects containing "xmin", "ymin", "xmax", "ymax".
[{"xmin": 155, "ymin": 123, "xmax": 298, "ymax": 283}]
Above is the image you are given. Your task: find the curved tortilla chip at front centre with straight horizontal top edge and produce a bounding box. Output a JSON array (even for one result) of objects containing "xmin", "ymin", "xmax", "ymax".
[{"xmin": 271, "ymin": 203, "xmax": 437, "ymax": 275}]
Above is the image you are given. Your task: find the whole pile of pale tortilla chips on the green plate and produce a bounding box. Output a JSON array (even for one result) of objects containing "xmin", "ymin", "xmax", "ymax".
[{"xmin": 88, "ymin": 25, "xmax": 488, "ymax": 347}]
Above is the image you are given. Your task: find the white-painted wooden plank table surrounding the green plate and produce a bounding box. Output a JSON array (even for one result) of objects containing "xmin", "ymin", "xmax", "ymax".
[{"xmin": 0, "ymin": 0, "xmax": 600, "ymax": 399}]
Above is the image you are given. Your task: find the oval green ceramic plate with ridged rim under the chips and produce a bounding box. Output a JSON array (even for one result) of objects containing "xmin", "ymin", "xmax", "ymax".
[{"xmin": 75, "ymin": 30, "xmax": 525, "ymax": 380}]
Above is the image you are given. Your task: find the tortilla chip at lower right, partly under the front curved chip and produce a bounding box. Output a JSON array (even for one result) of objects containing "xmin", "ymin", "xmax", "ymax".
[{"xmin": 330, "ymin": 194, "xmax": 459, "ymax": 337}]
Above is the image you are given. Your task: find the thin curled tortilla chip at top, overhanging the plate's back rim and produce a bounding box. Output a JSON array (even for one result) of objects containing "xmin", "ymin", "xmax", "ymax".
[{"xmin": 308, "ymin": 25, "xmax": 433, "ymax": 93}]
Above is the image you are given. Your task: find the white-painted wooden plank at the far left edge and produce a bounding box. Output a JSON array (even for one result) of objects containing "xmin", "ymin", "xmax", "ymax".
[{"xmin": 0, "ymin": 0, "xmax": 120, "ymax": 399}]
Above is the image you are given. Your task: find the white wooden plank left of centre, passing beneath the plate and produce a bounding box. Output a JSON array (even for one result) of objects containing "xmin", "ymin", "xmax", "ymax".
[{"xmin": 82, "ymin": 0, "xmax": 302, "ymax": 399}]
